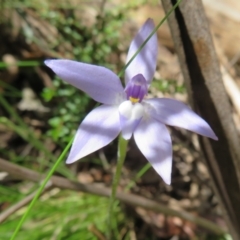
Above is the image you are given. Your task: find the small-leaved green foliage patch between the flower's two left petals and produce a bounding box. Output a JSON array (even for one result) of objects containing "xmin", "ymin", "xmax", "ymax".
[{"xmin": 42, "ymin": 79, "xmax": 90, "ymax": 143}]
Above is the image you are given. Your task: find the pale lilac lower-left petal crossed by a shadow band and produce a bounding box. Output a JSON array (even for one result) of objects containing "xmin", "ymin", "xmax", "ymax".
[{"xmin": 67, "ymin": 105, "xmax": 120, "ymax": 163}]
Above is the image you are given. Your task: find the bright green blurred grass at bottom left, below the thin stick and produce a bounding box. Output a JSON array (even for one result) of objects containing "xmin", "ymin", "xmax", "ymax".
[{"xmin": 0, "ymin": 189, "xmax": 125, "ymax": 240}]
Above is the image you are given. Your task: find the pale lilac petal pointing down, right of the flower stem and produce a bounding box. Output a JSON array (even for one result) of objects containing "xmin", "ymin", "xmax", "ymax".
[{"xmin": 133, "ymin": 118, "xmax": 172, "ymax": 184}]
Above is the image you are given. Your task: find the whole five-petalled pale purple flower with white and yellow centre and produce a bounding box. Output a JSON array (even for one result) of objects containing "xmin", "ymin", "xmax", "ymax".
[{"xmin": 45, "ymin": 19, "xmax": 217, "ymax": 184}]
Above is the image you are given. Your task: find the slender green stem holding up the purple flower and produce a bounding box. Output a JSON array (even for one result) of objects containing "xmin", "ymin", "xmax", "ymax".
[{"xmin": 107, "ymin": 135, "xmax": 128, "ymax": 240}]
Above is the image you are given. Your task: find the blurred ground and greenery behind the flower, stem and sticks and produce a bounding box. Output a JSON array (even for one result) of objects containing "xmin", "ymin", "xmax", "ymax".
[{"xmin": 0, "ymin": 0, "xmax": 240, "ymax": 240}]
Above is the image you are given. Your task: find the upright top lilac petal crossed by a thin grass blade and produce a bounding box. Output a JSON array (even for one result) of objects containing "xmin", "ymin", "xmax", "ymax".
[{"xmin": 125, "ymin": 19, "xmax": 158, "ymax": 85}]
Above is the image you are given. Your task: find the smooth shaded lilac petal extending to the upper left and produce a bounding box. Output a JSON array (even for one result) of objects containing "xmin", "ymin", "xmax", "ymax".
[{"xmin": 45, "ymin": 59, "xmax": 126, "ymax": 104}]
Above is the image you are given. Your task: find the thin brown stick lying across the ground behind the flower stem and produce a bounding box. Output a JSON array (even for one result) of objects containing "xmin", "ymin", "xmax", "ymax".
[{"xmin": 0, "ymin": 158, "xmax": 226, "ymax": 235}]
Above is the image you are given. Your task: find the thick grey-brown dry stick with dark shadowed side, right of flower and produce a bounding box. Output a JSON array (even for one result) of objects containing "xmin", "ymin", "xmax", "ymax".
[{"xmin": 162, "ymin": 0, "xmax": 240, "ymax": 240}]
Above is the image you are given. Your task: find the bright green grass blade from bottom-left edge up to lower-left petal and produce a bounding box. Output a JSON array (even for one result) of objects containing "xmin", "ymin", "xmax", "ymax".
[{"xmin": 10, "ymin": 139, "xmax": 73, "ymax": 240}]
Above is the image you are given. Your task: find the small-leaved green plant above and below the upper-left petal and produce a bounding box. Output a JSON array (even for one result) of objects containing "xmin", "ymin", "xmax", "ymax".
[{"xmin": 38, "ymin": 3, "xmax": 124, "ymax": 146}]
